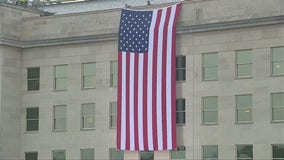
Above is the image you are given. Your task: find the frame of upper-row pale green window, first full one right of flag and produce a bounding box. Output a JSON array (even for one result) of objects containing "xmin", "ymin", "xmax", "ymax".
[{"xmin": 201, "ymin": 52, "xmax": 219, "ymax": 82}]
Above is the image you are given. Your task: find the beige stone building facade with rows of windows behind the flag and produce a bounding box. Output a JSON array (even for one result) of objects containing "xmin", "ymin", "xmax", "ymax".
[{"xmin": 0, "ymin": 0, "xmax": 284, "ymax": 160}]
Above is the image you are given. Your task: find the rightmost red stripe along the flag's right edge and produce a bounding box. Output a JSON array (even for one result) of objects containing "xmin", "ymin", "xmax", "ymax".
[{"xmin": 171, "ymin": 4, "xmax": 181, "ymax": 149}]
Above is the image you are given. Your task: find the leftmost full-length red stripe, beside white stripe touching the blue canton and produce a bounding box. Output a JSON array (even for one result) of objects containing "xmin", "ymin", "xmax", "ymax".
[{"xmin": 152, "ymin": 10, "xmax": 162, "ymax": 150}]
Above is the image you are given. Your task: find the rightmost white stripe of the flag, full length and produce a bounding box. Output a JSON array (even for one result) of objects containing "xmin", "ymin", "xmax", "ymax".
[{"xmin": 166, "ymin": 5, "xmax": 176, "ymax": 149}]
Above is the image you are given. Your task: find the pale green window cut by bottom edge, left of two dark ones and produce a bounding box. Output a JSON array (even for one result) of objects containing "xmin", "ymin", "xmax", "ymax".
[{"xmin": 202, "ymin": 145, "xmax": 218, "ymax": 160}]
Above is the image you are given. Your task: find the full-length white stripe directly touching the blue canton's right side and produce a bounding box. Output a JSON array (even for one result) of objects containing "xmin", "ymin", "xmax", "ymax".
[{"xmin": 147, "ymin": 10, "xmax": 157, "ymax": 150}]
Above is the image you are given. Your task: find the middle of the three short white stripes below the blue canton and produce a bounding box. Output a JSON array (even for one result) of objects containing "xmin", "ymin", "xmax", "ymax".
[{"xmin": 128, "ymin": 52, "xmax": 135, "ymax": 150}]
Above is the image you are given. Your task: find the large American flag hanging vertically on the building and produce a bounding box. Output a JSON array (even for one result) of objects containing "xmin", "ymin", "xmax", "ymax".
[{"xmin": 117, "ymin": 3, "xmax": 181, "ymax": 151}]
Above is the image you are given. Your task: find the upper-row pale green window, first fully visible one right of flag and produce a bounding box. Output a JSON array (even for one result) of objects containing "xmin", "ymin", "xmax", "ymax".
[{"xmin": 202, "ymin": 53, "xmax": 218, "ymax": 81}]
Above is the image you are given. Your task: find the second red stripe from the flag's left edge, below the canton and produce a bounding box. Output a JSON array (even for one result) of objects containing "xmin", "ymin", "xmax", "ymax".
[{"xmin": 125, "ymin": 52, "xmax": 130, "ymax": 150}]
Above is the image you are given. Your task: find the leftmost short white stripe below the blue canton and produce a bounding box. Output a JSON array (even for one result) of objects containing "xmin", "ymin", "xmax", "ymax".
[{"xmin": 120, "ymin": 52, "xmax": 126, "ymax": 150}]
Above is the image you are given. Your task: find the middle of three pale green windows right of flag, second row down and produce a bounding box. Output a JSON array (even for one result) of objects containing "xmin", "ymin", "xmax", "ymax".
[{"xmin": 236, "ymin": 95, "xmax": 252, "ymax": 123}]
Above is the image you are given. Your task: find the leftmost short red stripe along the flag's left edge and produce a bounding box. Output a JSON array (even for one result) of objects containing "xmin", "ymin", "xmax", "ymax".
[{"xmin": 116, "ymin": 51, "xmax": 122, "ymax": 149}]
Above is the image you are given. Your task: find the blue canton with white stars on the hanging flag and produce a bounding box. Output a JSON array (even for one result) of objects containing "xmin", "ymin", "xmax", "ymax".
[{"xmin": 118, "ymin": 9, "xmax": 153, "ymax": 53}]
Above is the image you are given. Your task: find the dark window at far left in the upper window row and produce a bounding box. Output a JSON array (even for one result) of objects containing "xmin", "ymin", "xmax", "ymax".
[{"xmin": 27, "ymin": 67, "xmax": 40, "ymax": 91}]
